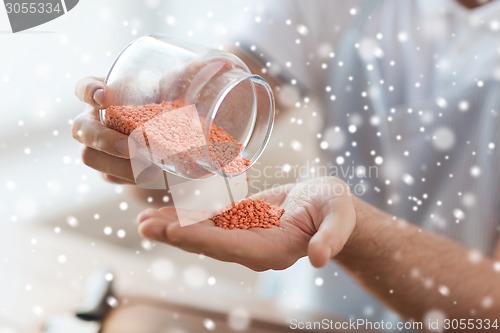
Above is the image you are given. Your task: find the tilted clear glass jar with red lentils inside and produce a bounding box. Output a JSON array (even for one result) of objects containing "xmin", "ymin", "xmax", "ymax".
[{"xmin": 100, "ymin": 35, "xmax": 274, "ymax": 180}]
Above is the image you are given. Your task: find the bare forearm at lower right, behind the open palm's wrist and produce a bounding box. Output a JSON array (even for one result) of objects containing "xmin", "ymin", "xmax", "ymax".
[{"xmin": 336, "ymin": 198, "xmax": 500, "ymax": 326}]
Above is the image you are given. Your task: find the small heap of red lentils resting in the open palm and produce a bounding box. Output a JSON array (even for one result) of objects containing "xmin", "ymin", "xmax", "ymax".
[{"xmin": 211, "ymin": 199, "xmax": 285, "ymax": 230}]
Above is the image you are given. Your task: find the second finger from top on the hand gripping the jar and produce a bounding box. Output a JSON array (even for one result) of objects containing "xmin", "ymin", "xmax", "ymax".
[{"xmin": 72, "ymin": 110, "xmax": 133, "ymax": 158}]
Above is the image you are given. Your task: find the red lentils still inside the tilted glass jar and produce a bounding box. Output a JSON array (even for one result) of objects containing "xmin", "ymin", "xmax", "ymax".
[{"xmin": 105, "ymin": 100, "xmax": 250, "ymax": 177}]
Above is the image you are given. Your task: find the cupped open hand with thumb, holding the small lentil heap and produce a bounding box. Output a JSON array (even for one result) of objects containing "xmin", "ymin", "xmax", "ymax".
[{"xmin": 138, "ymin": 177, "xmax": 356, "ymax": 271}]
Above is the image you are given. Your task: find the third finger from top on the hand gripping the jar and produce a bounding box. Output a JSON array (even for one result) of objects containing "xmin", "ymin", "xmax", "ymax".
[{"xmin": 82, "ymin": 147, "xmax": 135, "ymax": 183}]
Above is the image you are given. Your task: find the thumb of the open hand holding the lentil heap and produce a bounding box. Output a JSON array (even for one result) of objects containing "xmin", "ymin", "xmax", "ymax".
[{"xmin": 307, "ymin": 197, "xmax": 356, "ymax": 267}]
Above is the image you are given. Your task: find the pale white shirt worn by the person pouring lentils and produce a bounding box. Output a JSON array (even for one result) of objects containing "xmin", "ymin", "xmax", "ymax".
[{"xmin": 239, "ymin": 0, "xmax": 500, "ymax": 321}]
